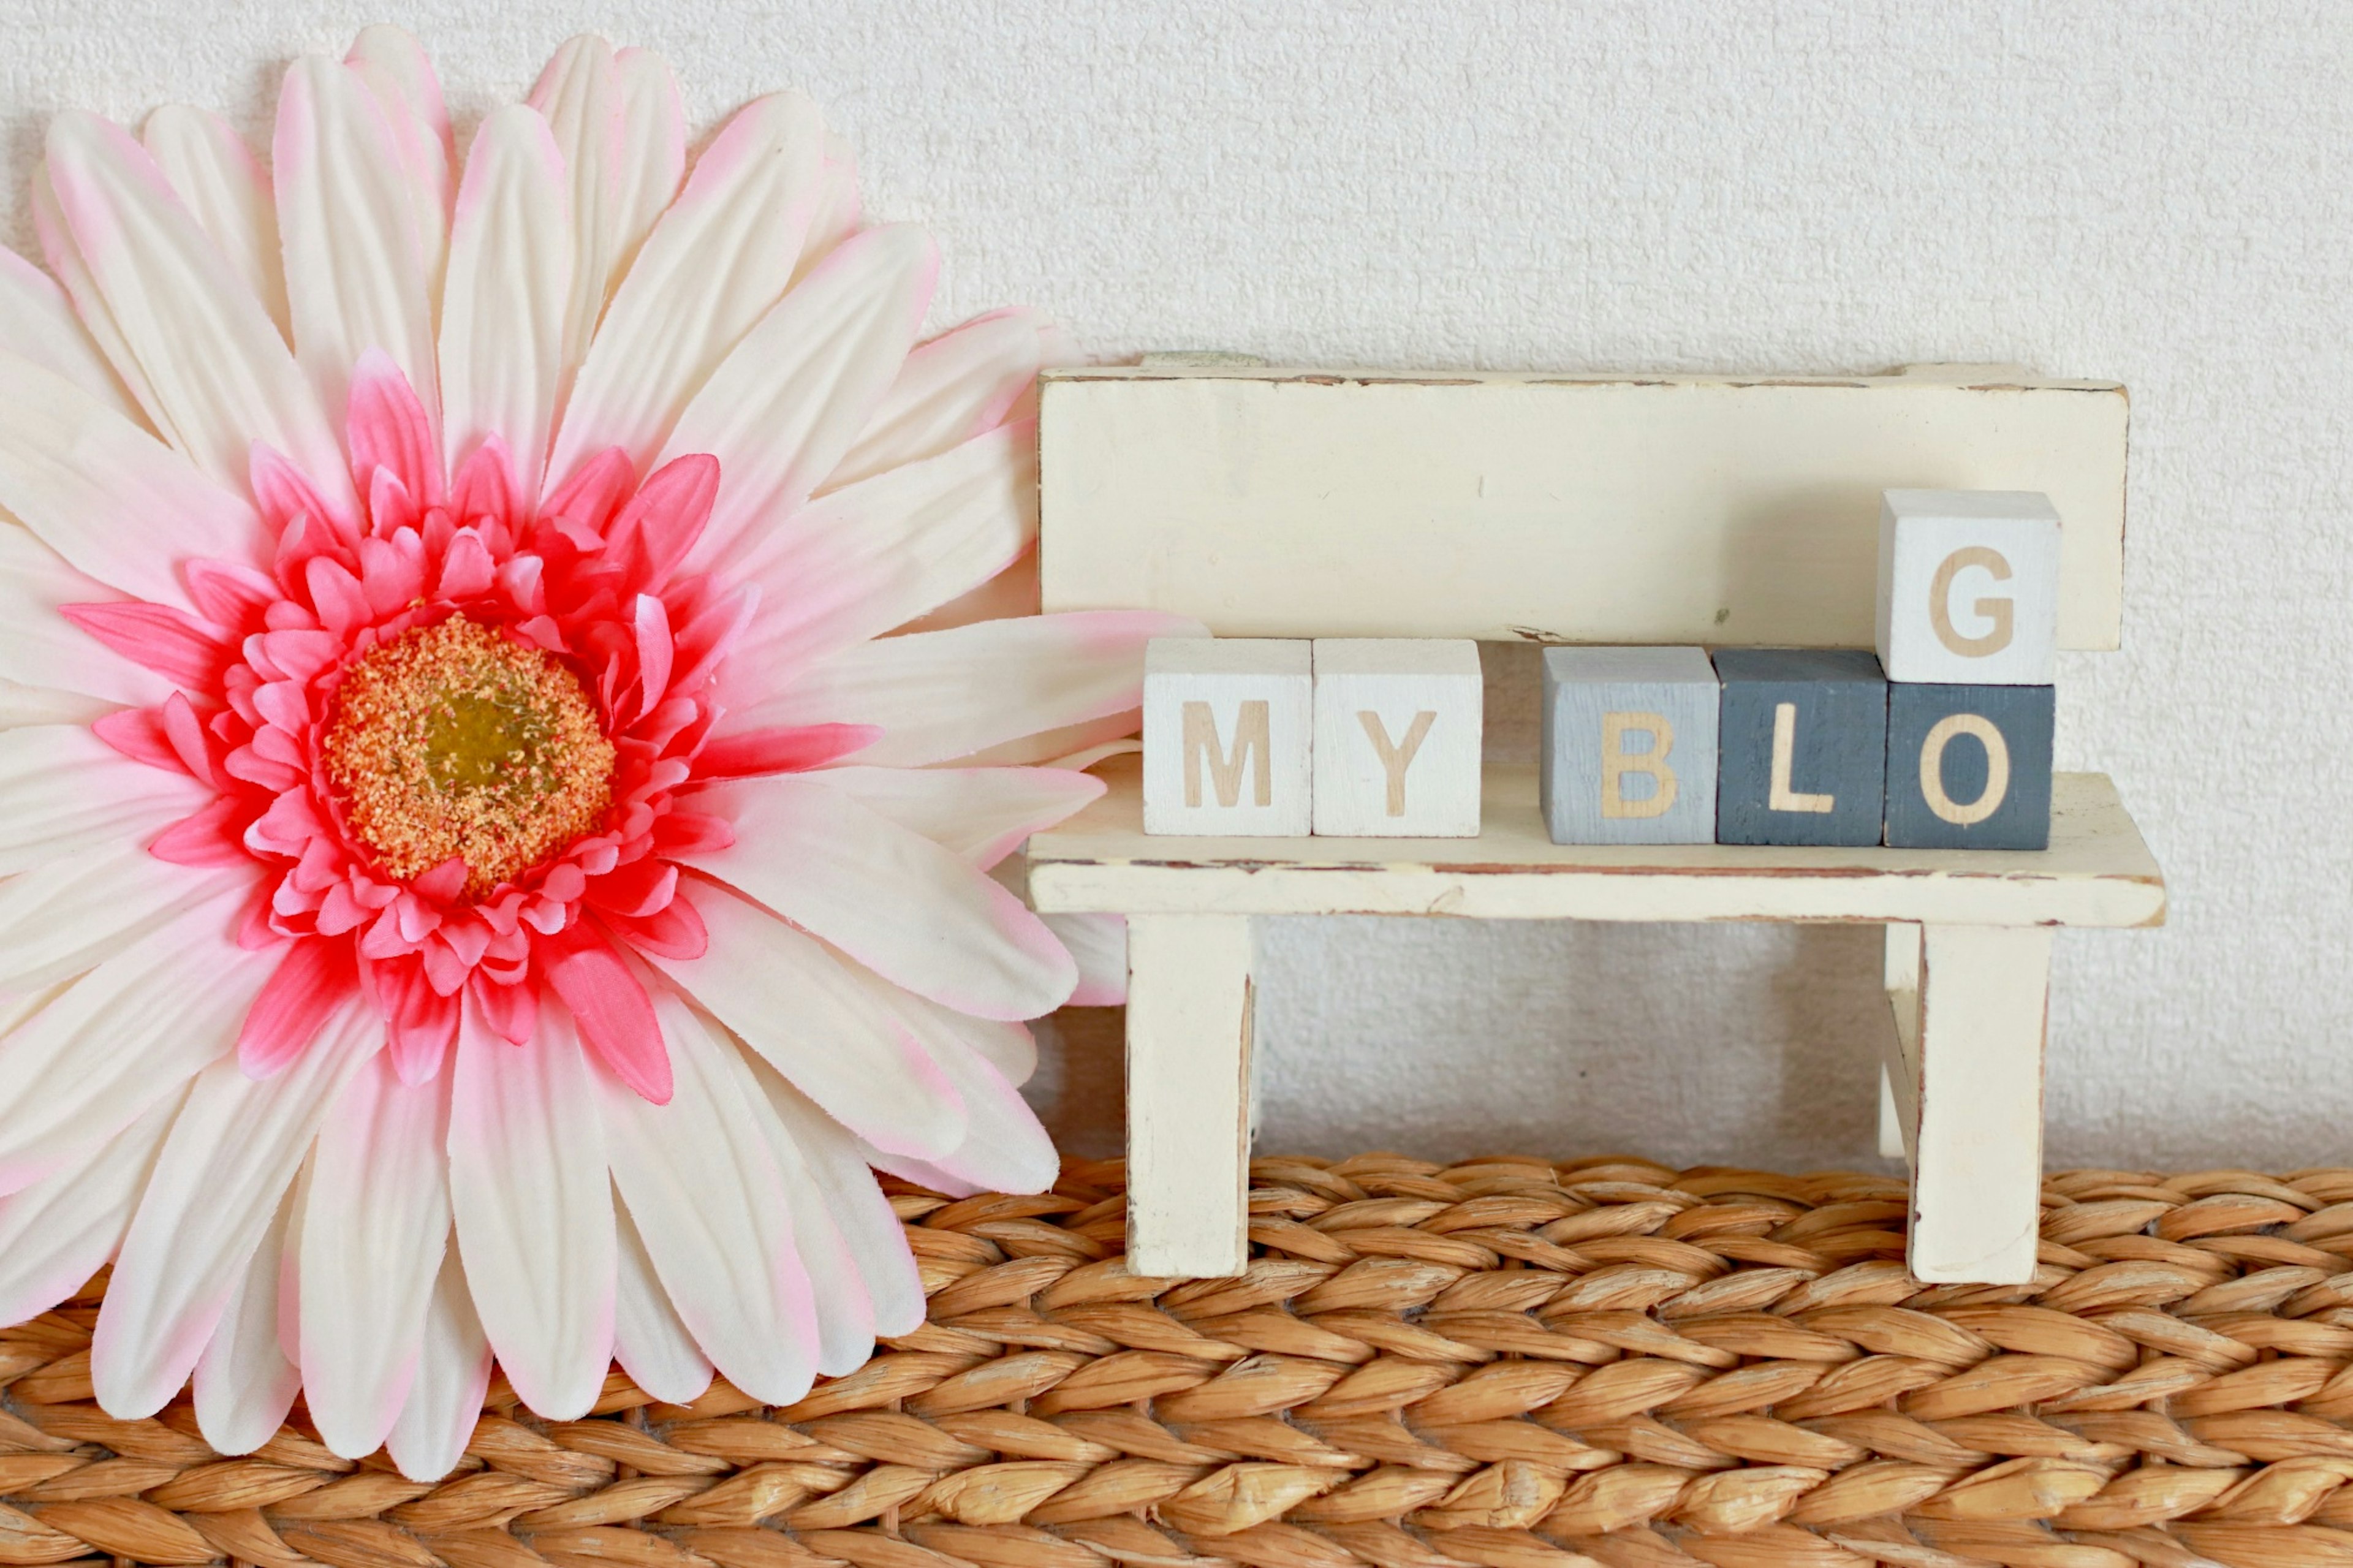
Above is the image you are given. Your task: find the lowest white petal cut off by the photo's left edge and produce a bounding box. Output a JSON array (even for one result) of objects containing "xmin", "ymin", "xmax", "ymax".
[{"xmin": 0, "ymin": 1095, "xmax": 181, "ymax": 1323}]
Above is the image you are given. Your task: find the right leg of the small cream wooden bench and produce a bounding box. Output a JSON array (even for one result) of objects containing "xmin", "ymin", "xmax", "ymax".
[{"xmin": 1885, "ymin": 925, "xmax": 2052, "ymax": 1286}]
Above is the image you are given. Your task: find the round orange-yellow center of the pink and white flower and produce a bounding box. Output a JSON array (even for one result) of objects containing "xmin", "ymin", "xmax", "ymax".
[{"xmin": 325, "ymin": 617, "xmax": 614, "ymax": 897}]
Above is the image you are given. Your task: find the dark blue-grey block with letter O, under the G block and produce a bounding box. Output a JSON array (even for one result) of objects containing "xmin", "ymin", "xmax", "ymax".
[{"xmin": 1887, "ymin": 680, "xmax": 2056, "ymax": 850}]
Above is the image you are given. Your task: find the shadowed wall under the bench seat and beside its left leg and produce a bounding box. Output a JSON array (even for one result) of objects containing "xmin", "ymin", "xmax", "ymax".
[{"xmin": 1028, "ymin": 916, "xmax": 1887, "ymax": 1170}]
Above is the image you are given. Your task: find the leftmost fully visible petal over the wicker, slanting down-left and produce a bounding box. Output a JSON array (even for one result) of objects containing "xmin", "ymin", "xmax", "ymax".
[{"xmin": 85, "ymin": 1002, "xmax": 384, "ymax": 1420}]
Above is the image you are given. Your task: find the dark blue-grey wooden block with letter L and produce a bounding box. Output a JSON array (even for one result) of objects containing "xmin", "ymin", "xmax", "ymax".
[{"xmin": 1715, "ymin": 648, "xmax": 1887, "ymax": 845}]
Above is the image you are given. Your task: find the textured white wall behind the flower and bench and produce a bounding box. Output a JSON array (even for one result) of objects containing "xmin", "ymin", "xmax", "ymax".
[{"xmin": 0, "ymin": 0, "xmax": 2353, "ymax": 1165}]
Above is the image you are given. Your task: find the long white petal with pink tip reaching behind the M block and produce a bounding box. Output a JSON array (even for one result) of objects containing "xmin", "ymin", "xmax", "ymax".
[{"xmin": 720, "ymin": 610, "xmax": 1202, "ymax": 768}]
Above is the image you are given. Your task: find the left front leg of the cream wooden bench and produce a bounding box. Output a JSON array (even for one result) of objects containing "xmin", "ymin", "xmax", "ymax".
[{"xmin": 1127, "ymin": 914, "xmax": 1252, "ymax": 1276}]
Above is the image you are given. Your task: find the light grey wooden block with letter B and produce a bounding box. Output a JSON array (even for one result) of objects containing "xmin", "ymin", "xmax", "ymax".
[{"xmin": 1539, "ymin": 648, "xmax": 1718, "ymax": 843}]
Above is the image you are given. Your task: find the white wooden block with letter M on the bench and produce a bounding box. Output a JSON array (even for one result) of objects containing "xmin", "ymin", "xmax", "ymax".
[{"xmin": 1143, "ymin": 638, "xmax": 1316, "ymax": 838}]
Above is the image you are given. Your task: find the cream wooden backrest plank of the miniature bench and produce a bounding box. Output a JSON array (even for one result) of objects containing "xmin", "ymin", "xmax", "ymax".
[{"xmin": 1037, "ymin": 365, "xmax": 2127, "ymax": 650}]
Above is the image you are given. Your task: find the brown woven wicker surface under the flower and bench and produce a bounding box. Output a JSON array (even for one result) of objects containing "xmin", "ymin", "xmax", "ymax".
[{"xmin": 0, "ymin": 1156, "xmax": 2353, "ymax": 1568}]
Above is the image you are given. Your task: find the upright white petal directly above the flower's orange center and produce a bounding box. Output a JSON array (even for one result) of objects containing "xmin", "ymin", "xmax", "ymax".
[{"xmin": 440, "ymin": 104, "xmax": 572, "ymax": 494}]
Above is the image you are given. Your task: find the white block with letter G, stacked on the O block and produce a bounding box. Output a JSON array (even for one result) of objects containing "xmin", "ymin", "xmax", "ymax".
[{"xmin": 1880, "ymin": 490, "xmax": 2059, "ymax": 685}]
